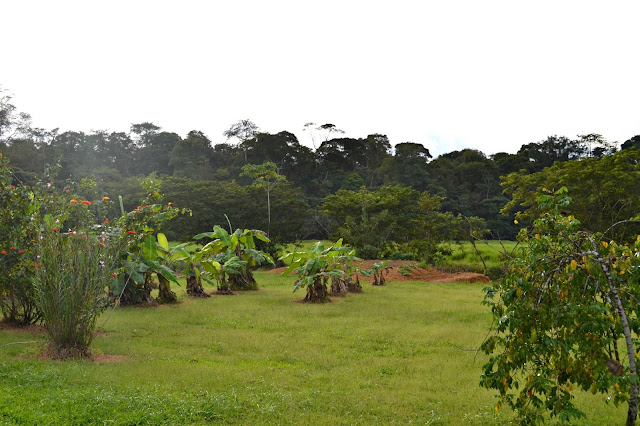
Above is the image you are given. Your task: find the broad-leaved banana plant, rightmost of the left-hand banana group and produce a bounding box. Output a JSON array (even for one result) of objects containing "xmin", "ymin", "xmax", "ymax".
[{"xmin": 194, "ymin": 225, "xmax": 273, "ymax": 290}]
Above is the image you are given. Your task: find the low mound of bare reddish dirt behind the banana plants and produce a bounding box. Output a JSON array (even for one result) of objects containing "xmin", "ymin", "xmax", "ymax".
[{"xmin": 269, "ymin": 260, "xmax": 490, "ymax": 283}]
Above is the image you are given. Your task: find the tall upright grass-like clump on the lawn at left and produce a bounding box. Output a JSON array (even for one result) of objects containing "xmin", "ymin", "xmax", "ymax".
[{"xmin": 34, "ymin": 228, "xmax": 117, "ymax": 359}]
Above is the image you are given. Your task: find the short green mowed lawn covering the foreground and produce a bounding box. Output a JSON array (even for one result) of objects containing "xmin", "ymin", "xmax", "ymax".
[{"xmin": 0, "ymin": 272, "xmax": 626, "ymax": 425}]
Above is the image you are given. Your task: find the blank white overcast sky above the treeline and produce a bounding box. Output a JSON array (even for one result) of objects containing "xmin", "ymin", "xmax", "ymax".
[{"xmin": 0, "ymin": 0, "xmax": 640, "ymax": 155}]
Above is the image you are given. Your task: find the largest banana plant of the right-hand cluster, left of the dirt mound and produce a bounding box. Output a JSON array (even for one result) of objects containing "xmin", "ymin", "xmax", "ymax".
[{"xmin": 280, "ymin": 239, "xmax": 357, "ymax": 303}]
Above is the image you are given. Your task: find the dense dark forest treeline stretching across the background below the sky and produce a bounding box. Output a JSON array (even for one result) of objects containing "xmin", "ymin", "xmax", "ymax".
[{"xmin": 0, "ymin": 89, "xmax": 640, "ymax": 255}]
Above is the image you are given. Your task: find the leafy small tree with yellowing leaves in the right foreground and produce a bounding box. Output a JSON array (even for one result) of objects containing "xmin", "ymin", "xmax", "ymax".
[{"xmin": 481, "ymin": 188, "xmax": 640, "ymax": 425}]
